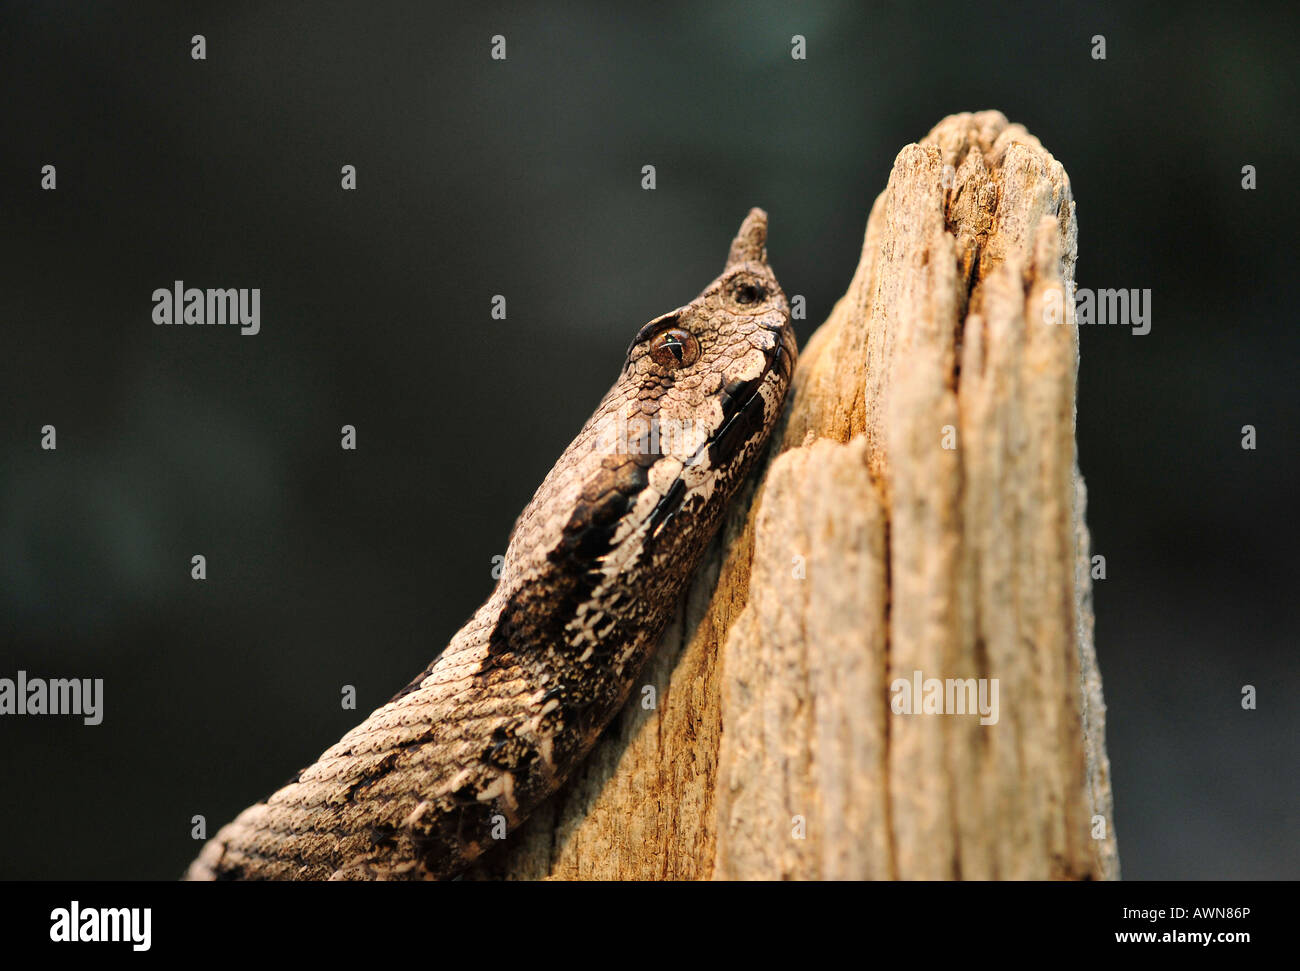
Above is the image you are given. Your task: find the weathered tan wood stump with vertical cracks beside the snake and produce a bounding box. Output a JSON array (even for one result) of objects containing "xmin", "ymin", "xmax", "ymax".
[{"xmin": 472, "ymin": 112, "xmax": 1118, "ymax": 879}]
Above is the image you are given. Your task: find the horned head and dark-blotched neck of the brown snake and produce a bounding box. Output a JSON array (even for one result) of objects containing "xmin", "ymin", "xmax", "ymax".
[{"xmin": 495, "ymin": 209, "xmax": 796, "ymax": 636}]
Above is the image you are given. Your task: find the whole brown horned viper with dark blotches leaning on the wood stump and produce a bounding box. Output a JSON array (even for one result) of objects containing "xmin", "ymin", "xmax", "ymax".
[{"xmin": 186, "ymin": 209, "xmax": 796, "ymax": 880}]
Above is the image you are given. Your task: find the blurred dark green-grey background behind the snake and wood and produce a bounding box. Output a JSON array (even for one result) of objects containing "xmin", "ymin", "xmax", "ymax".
[{"xmin": 0, "ymin": 3, "xmax": 1300, "ymax": 877}]
